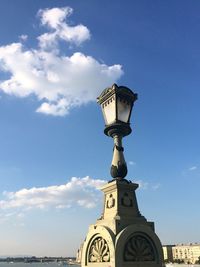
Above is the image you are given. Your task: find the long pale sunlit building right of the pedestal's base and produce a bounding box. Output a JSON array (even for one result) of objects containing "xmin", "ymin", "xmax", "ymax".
[{"xmin": 163, "ymin": 243, "xmax": 200, "ymax": 264}]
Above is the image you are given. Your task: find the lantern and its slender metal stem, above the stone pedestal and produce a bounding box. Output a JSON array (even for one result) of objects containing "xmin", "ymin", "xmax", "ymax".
[{"xmin": 97, "ymin": 84, "xmax": 137, "ymax": 180}]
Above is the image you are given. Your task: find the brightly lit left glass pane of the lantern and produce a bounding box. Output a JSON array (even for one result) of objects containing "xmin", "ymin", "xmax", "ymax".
[{"xmin": 101, "ymin": 97, "xmax": 116, "ymax": 125}]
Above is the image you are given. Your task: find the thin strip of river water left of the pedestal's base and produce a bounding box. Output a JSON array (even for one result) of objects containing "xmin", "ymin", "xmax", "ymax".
[{"xmin": 0, "ymin": 262, "xmax": 80, "ymax": 267}]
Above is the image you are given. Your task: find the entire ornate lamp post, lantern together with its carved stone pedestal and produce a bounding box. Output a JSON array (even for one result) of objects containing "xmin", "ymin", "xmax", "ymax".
[{"xmin": 81, "ymin": 84, "xmax": 163, "ymax": 267}]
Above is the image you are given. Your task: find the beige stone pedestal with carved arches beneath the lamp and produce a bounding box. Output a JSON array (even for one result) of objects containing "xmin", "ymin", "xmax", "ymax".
[{"xmin": 81, "ymin": 179, "xmax": 163, "ymax": 267}]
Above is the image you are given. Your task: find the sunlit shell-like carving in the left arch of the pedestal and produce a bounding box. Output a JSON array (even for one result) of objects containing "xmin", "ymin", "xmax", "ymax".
[{"xmin": 89, "ymin": 237, "xmax": 110, "ymax": 263}]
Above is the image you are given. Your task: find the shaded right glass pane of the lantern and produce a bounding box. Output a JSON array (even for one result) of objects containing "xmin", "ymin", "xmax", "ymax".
[{"xmin": 117, "ymin": 97, "xmax": 131, "ymax": 123}]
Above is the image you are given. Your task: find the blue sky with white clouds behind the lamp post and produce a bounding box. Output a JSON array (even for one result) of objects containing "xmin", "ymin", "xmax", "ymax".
[{"xmin": 0, "ymin": 0, "xmax": 200, "ymax": 256}]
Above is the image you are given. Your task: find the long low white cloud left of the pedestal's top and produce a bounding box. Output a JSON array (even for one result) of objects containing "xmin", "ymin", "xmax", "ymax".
[{"xmin": 0, "ymin": 176, "xmax": 106, "ymax": 213}]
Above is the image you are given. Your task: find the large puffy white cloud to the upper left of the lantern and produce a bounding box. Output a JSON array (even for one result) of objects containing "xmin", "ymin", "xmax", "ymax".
[{"xmin": 0, "ymin": 7, "xmax": 123, "ymax": 116}]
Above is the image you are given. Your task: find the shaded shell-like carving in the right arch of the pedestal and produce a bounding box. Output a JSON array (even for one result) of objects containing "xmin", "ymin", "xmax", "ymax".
[{"xmin": 124, "ymin": 234, "xmax": 156, "ymax": 262}]
